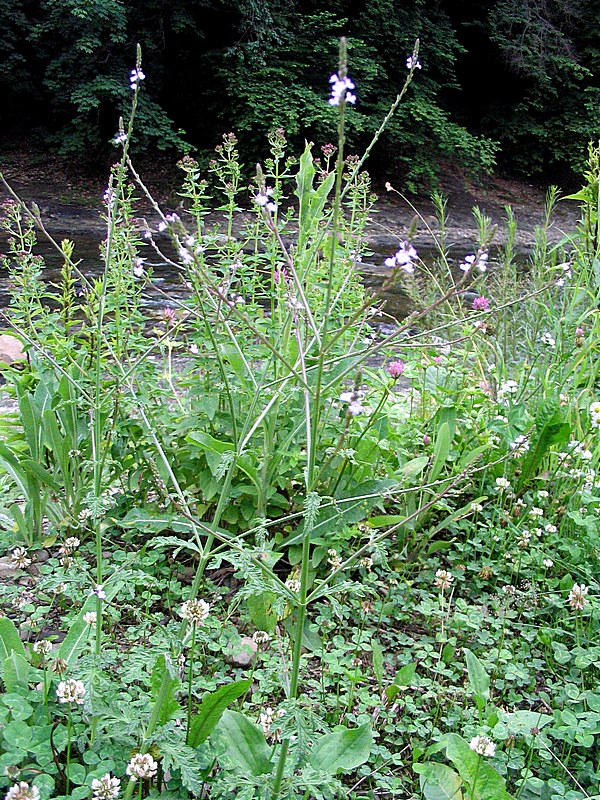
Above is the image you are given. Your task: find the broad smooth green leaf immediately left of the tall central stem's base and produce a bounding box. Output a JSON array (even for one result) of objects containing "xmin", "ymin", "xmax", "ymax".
[{"xmin": 217, "ymin": 711, "xmax": 273, "ymax": 776}]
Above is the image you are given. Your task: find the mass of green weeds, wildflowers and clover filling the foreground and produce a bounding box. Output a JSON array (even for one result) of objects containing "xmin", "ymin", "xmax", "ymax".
[{"xmin": 0, "ymin": 43, "xmax": 600, "ymax": 800}]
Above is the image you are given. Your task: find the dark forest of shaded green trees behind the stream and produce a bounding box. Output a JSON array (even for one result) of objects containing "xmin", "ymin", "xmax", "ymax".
[{"xmin": 0, "ymin": 0, "xmax": 600, "ymax": 189}]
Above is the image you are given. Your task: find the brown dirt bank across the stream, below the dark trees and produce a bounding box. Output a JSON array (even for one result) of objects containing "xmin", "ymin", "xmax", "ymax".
[{"xmin": 0, "ymin": 148, "xmax": 579, "ymax": 253}]
